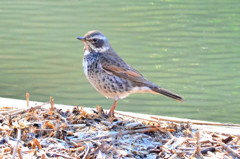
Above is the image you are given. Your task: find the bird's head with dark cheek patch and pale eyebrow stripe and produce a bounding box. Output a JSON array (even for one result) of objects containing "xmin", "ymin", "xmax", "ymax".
[{"xmin": 77, "ymin": 30, "xmax": 111, "ymax": 53}]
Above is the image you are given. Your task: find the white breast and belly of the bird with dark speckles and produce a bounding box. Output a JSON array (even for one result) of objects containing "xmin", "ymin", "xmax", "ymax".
[{"xmin": 83, "ymin": 53, "xmax": 132, "ymax": 99}]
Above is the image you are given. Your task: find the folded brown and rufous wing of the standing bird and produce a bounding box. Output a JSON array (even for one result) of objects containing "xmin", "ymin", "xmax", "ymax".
[{"xmin": 100, "ymin": 54, "xmax": 148, "ymax": 83}]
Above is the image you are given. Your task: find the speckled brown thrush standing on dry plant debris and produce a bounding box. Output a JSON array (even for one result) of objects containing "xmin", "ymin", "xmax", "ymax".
[{"xmin": 77, "ymin": 30, "xmax": 183, "ymax": 117}]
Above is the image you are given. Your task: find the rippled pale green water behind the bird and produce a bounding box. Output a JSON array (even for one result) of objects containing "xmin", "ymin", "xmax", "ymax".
[{"xmin": 0, "ymin": 0, "xmax": 240, "ymax": 123}]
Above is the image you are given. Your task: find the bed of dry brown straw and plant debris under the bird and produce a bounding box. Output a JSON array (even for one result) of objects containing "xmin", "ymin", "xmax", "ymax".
[{"xmin": 0, "ymin": 95, "xmax": 240, "ymax": 159}]
